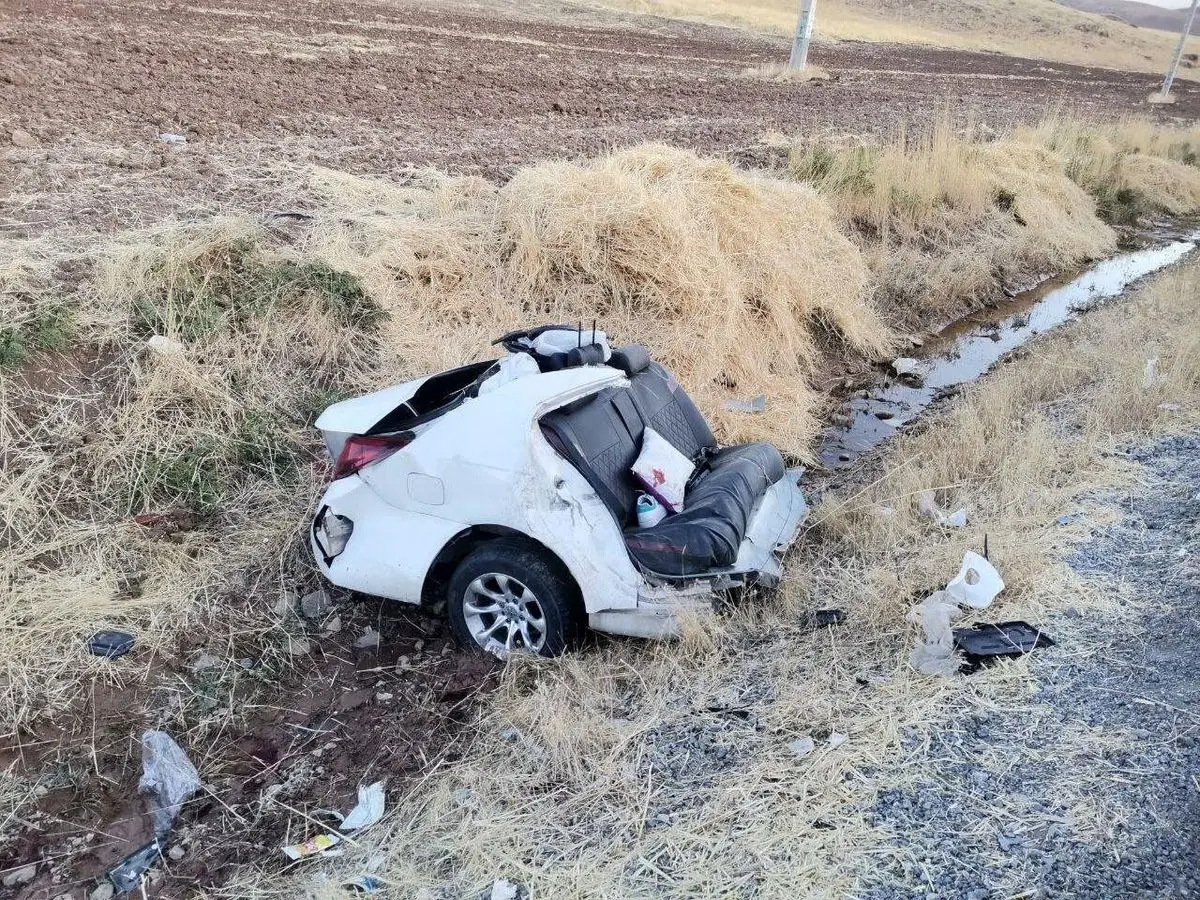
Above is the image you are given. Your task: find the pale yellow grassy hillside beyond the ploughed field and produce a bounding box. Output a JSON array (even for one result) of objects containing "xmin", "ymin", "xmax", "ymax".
[{"xmin": 606, "ymin": 0, "xmax": 1193, "ymax": 78}]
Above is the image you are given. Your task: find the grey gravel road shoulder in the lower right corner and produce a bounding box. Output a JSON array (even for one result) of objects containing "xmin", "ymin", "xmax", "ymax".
[{"xmin": 865, "ymin": 433, "xmax": 1200, "ymax": 900}]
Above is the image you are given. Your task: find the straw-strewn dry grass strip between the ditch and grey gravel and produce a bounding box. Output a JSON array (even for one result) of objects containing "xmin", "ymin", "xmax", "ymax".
[{"xmin": 223, "ymin": 252, "xmax": 1200, "ymax": 898}]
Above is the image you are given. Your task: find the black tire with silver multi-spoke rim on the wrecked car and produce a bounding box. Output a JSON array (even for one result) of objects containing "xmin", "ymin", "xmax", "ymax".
[{"xmin": 446, "ymin": 538, "xmax": 584, "ymax": 658}]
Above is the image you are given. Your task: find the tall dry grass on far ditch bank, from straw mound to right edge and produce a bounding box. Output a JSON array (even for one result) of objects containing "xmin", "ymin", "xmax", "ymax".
[{"xmin": 772, "ymin": 116, "xmax": 1200, "ymax": 328}]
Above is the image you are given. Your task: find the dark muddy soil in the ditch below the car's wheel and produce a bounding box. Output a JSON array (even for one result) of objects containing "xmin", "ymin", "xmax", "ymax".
[{"xmin": 0, "ymin": 596, "xmax": 498, "ymax": 900}]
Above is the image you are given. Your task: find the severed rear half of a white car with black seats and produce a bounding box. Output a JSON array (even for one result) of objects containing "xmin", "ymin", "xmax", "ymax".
[{"xmin": 311, "ymin": 326, "xmax": 808, "ymax": 658}]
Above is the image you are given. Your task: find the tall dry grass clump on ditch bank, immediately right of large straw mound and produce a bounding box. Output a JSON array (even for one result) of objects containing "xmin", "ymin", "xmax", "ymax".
[{"xmin": 788, "ymin": 122, "xmax": 1116, "ymax": 328}]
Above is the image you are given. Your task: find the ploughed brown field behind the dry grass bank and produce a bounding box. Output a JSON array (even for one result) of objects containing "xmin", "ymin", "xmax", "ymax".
[{"xmin": 0, "ymin": 0, "xmax": 1200, "ymax": 243}]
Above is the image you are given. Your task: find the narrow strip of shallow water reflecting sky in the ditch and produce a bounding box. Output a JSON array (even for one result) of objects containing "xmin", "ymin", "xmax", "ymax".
[{"xmin": 821, "ymin": 230, "xmax": 1200, "ymax": 469}]
